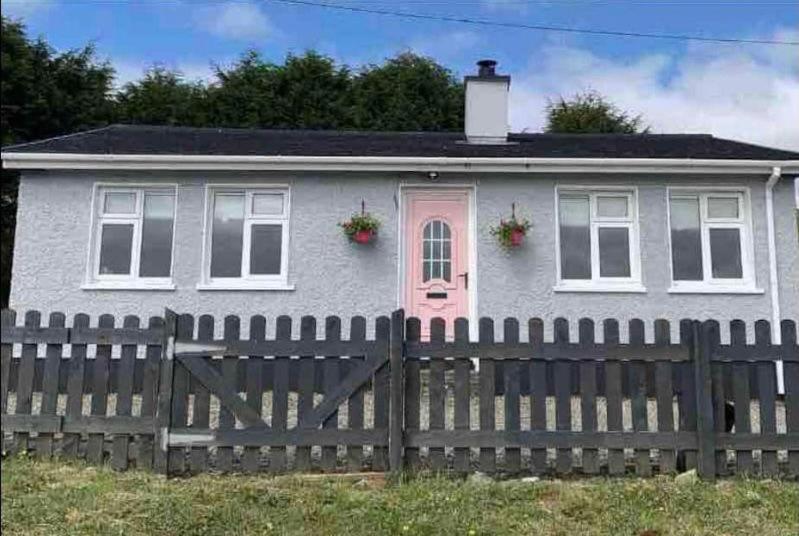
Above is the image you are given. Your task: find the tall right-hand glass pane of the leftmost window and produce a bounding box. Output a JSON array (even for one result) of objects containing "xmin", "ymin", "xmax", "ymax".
[{"xmin": 139, "ymin": 194, "xmax": 175, "ymax": 277}]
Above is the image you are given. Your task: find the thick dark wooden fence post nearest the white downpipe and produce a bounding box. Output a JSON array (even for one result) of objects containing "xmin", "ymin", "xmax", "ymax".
[{"xmin": 691, "ymin": 320, "xmax": 718, "ymax": 482}]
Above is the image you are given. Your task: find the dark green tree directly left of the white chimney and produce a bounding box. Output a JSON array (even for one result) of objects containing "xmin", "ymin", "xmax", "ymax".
[{"xmin": 353, "ymin": 52, "xmax": 464, "ymax": 131}]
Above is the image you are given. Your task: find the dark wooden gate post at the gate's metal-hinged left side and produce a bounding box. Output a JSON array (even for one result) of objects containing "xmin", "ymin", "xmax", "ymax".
[{"xmin": 153, "ymin": 309, "xmax": 177, "ymax": 475}]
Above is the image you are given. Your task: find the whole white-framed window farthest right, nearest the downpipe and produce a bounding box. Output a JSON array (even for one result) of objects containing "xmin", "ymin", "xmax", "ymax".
[{"xmin": 669, "ymin": 190, "xmax": 754, "ymax": 291}]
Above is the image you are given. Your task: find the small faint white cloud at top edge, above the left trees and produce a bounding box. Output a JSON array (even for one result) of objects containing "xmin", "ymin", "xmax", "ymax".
[{"xmin": 194, "ymin": 2, "xmax": 272, "ymax": 41}]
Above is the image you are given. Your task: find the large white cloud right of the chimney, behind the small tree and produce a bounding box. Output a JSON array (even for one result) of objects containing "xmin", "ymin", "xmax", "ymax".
[{"xmin": 511, "ymin": 31, "xmax": 799, "ymax": 149}]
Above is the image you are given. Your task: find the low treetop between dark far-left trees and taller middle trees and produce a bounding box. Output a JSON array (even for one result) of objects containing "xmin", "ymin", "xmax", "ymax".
[{"xmin": 115, "ymin": 66, "xmax": 210, "ymax": 126}]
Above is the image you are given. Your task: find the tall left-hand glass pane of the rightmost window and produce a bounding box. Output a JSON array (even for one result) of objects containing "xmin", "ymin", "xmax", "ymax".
[{"xmin": 670, "ymin": 198, "xmax": 703, "ymax": 281}]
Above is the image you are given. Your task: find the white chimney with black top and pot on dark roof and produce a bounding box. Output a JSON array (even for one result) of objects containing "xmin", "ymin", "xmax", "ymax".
[{"xmin": 464, "ymin": 60, "xmax": 510, "ymax": 145}]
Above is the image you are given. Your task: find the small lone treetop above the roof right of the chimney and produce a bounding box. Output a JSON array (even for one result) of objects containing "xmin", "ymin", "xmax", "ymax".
[{"xmin": 546, "ymin": 92, "xmax": 649, "ymax": 134}]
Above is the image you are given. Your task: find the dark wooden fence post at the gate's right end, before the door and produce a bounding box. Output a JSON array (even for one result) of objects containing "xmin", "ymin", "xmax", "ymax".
[{"xmin": 388, "ymin": 309, "xmax": 405, "ymax": 472}]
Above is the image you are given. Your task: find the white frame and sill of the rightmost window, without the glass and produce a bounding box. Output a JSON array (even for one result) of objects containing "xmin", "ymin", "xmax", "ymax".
[{"xmin": 666, "ymin": 186, "xmax": 763, "ymax": 294}]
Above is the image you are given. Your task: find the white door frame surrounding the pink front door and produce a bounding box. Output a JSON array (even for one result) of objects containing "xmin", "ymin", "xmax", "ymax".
[{"xmin": 397, "ymin": 181, "xmax": 478, "ymax": 341}]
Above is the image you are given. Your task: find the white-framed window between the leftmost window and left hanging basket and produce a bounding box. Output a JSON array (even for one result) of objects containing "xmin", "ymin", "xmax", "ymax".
[{"xmin": 200, "ymin": 187, "xmax": 289, "ymax": 289}]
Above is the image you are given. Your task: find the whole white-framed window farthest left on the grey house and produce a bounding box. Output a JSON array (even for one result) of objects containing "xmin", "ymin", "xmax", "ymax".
[{"xmin": 86, "ymin": 186, "xmax": 175, "ymax": 288}]
